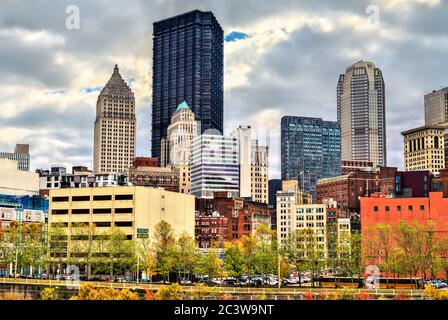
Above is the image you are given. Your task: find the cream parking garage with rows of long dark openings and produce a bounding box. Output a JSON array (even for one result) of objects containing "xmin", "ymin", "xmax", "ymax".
[{"xmin": 48, "ymin": 186, "xmax": 195, "ymax": 255}]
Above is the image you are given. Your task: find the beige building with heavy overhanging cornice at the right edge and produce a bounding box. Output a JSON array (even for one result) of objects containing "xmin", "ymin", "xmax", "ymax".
[{"xmin": 401, "ymin": 123, "xmax": 448, "ymax": 172}]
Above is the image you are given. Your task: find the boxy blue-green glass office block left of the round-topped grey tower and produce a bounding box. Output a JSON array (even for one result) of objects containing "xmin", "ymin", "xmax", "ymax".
[{"xmin": 281, "ymin": 116, "xmax": 341, "ymax": 200}]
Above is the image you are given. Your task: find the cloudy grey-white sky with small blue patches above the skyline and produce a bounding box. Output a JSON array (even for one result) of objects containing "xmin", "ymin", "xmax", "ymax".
[{"xmin": 0, "ymin": 0, "xmax": 448, "ymax": 178}]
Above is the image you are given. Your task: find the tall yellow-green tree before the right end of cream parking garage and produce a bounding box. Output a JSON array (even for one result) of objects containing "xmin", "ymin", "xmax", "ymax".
[{"xmin": 154, "ymin": 221, "xmax": 176, "ymax": 282}]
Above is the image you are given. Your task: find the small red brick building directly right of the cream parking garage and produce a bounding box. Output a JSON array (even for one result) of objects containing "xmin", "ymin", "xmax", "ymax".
[{"xmin": 195, "ymin": 213, "xmax": 229, "ymax": 248}]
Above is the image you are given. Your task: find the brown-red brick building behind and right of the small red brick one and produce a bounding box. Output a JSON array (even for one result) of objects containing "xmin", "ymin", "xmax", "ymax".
[{"xmin": 196, "ymin": 192, "xmax": 273, "ymax": 240}]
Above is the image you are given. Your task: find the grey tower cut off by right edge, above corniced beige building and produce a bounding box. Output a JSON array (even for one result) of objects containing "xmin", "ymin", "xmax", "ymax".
[{"xmin": 425, "ymin": 87, "xmax": 448, "ymax": 126}]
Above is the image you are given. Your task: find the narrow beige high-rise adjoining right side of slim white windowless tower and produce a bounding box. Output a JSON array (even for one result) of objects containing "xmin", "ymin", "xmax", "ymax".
[{"xmin": 251, "ymin": 141, "xmax": 269, "ymax": 203}]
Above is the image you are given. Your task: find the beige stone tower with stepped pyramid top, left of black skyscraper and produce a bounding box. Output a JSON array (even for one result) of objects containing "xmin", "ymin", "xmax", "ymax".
[{"xmin": 93, "ymin": 65, "xmax": 136, "ymax": 173}]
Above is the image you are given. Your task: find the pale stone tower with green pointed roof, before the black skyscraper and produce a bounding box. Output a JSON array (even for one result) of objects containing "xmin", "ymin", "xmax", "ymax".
[{"xmin": 160, "ymin": 101, "xmax": 200, "ymax": 167}]
